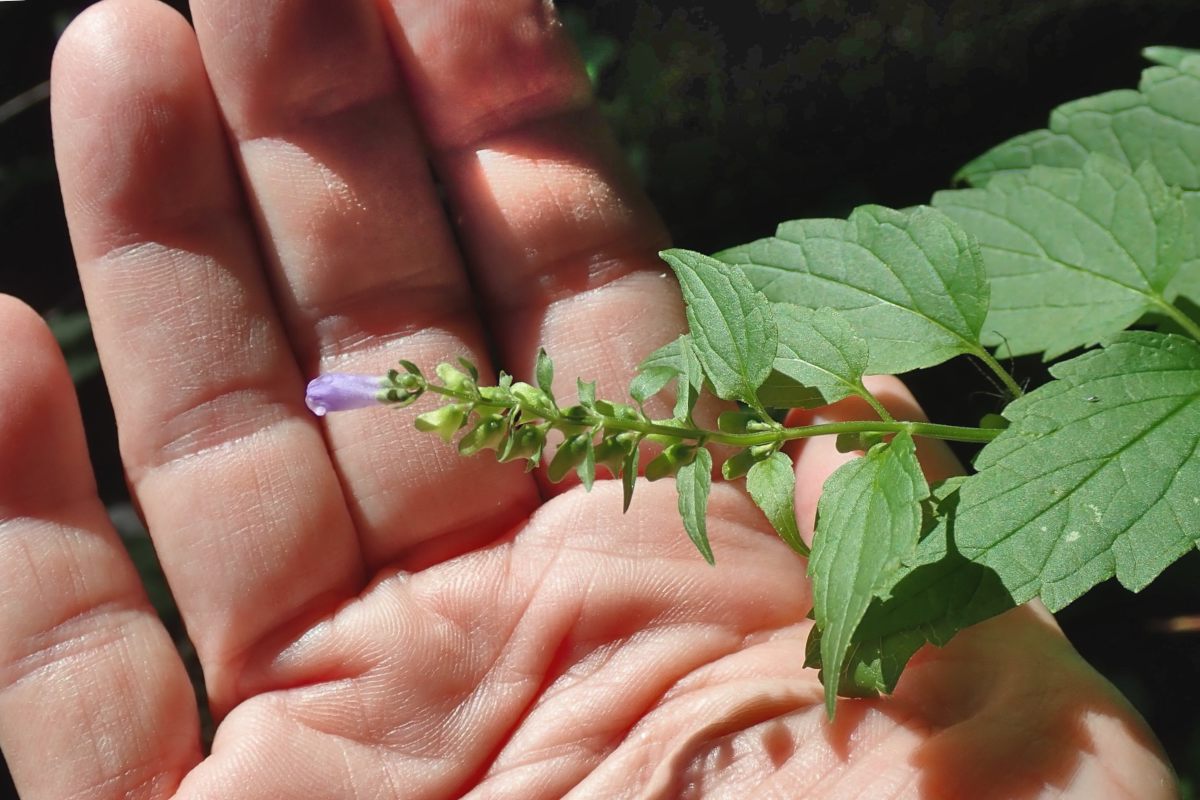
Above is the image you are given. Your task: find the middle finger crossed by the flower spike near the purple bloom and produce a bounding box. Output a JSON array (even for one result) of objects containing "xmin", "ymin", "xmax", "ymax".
[{"xmin": 193, "ymin": 0, "xmax": 536, "ymax": 566}]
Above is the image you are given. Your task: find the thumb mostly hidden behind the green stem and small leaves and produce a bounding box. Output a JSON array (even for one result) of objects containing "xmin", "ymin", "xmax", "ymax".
[{"xmin": 790, "ymin": 375, "xmax": 962, "ymax": 545}]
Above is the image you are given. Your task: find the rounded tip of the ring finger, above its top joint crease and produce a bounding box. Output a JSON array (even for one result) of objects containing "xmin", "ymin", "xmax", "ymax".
[{"xmin": 50, "ymin": 0, "xmax": 229, "ymax": 261}]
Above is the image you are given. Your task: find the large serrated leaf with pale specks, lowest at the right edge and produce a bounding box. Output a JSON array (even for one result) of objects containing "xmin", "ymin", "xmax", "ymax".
[{"xmin": 955, "ymin": 331, "xmax": 1200, "ymax": 610}]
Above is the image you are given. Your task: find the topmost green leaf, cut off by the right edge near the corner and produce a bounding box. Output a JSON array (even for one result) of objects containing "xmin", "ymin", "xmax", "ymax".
[{"xmin": 955, "ymin": 48, "xmax": 1200, "ymax": 190}]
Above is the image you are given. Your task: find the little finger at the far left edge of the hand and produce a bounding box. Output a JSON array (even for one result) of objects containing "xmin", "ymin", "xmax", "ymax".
[{"xmin": 0, "ymin": 295, "xmax": 200, "ymax": 800}]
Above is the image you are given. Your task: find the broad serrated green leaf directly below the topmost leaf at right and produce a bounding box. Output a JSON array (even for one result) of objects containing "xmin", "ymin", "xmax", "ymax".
[{"xmin": 934, "ymin": 156, "xmax": 1190, "ymax": 360}]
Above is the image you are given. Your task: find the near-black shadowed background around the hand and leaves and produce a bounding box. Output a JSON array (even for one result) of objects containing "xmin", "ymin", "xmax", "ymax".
[{"xmin": 0, "ymin": 0, "xmax": 1200, "ymax": 796}]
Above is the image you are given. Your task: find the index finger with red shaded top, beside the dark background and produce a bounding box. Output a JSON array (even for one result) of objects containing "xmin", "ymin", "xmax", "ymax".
[{"xmin": 386, "ymin": 0, "xmax": 683, "ymax": 412}]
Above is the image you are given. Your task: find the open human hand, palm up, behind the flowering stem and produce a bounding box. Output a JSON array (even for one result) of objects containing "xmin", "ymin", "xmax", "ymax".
[{"xmin": 0, "ymin": 0, "xmax": 1175, "ymax": 800}]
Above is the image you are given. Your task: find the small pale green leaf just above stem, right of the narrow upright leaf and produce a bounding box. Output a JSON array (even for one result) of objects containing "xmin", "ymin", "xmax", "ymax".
[{"xmin": 772, "ymin": 302, "xmax": 869, "ymax": 408}]
